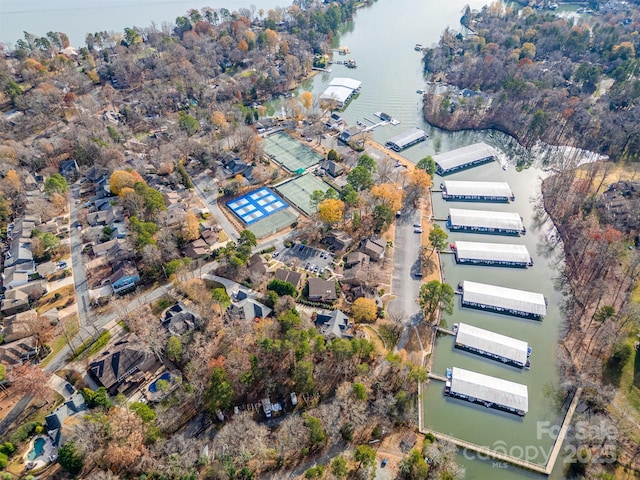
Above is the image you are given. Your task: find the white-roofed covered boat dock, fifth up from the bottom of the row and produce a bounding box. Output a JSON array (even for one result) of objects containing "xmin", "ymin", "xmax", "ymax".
[{"xmin": 447, "ymin": 208, "xmax": 527, "ymax": 235}]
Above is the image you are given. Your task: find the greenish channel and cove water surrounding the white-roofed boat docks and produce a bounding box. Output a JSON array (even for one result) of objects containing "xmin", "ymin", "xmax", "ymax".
[{"xmin": 308, "ymin": 0, "xmax": 563, "ymax": 480}]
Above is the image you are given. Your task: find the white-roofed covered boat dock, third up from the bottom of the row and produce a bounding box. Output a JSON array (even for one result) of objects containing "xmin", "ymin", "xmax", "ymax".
[{"xmin": 461, "ymin": 280, "xmax": 547, "ymax": 319}]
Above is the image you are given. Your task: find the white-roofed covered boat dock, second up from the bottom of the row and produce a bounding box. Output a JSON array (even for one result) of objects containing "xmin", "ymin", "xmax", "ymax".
[{"xmin": 455, "ymin": 323, "xmax": 529, "ymax": 368}]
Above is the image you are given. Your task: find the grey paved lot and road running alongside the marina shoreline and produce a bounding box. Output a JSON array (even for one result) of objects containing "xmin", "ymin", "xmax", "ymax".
[{"xmin": 389, "ymin": 206, "xmax": 422, "ymax": 349}]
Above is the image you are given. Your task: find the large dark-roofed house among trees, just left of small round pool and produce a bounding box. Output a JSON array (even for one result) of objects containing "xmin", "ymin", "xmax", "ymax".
[{"xmin": 88, "ymin": 344, "xmax": 159, "ymax": 395}]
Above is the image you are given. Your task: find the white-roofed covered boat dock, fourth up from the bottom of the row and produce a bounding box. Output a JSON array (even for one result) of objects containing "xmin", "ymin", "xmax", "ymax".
[{"xmin": 452, "ymin": 241, "xmax": 533, "ymax": 267}]
